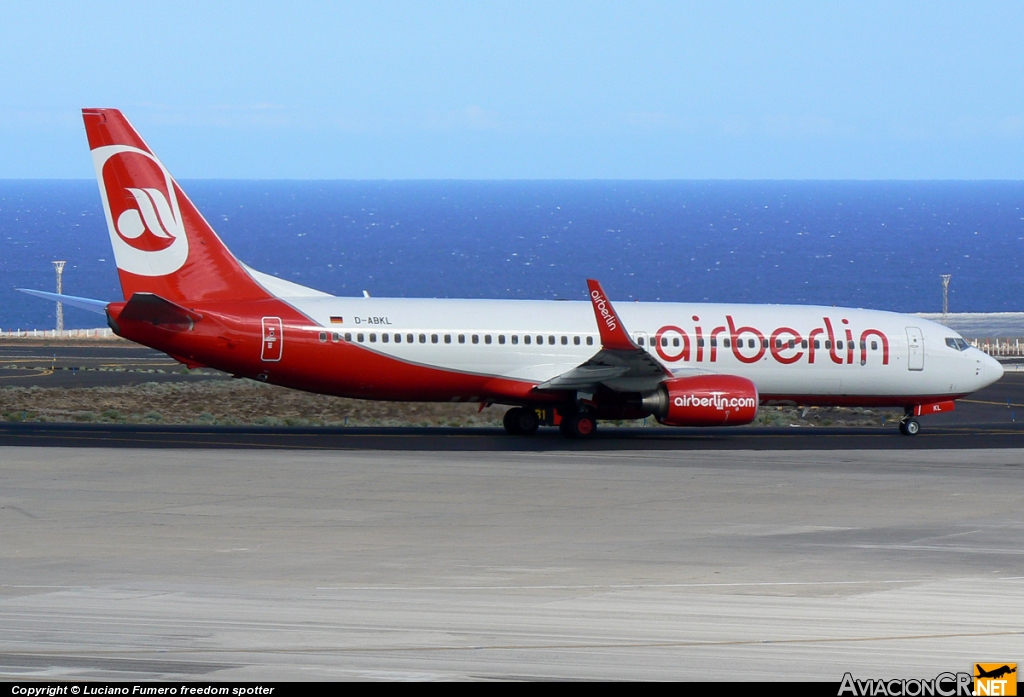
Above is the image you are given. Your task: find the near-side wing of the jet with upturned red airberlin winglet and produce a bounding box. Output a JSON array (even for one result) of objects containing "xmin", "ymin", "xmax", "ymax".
[{"xmin": 537, "ymin": 278, "xmax": 673, "ymax": 392}]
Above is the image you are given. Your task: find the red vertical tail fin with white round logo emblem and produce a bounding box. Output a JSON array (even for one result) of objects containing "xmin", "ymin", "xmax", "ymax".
[{"xmin": 82, "ymin": 108, "xmax": 269, "ymax": 302}]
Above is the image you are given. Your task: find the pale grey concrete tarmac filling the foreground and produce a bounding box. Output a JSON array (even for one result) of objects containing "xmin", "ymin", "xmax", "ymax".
[{"xmin": 0, "ymin": 447, "xmax": 1024, "ymax": 682}]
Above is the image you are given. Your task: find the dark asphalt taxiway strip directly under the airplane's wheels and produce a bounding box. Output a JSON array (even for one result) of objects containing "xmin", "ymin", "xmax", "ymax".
[{"xmin": 8, "ymin": 423, "xmax": 1024, "ymax": 452}]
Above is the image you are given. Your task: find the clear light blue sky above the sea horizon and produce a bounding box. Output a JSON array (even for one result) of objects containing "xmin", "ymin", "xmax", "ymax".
[{"xmin": 0, "ymin": 0, "xmax": 1024, "ymax": 179}]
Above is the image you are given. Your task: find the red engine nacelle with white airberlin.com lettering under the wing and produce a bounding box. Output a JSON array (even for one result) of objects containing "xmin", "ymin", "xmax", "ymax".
[{"xmin": 642, "ymin": 375, "xmax": 758, "ymax": 426}]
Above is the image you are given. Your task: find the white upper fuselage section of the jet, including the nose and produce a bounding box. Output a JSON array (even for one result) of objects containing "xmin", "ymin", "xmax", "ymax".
[{"xmin": 282, "ymin": 296, "xmax": 1002, "ymax": 404}]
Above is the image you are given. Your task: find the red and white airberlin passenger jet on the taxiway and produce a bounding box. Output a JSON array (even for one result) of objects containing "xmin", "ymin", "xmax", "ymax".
[{"xmin": 18, "ymin": 108, "xmax": 1002, "ymax": 438}]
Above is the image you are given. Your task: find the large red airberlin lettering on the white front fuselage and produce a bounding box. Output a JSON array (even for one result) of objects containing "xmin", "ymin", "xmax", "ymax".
[{"xmin": 655, "ymin": 314, "xmax": 889, "ymax": 365}]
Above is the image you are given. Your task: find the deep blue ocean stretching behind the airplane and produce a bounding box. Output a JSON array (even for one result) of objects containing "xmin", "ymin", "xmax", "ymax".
[{"xmin": 0, "ymin": 180, "xmax": 1024, "ymax": 329}]
